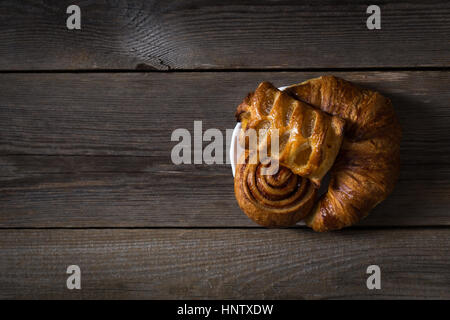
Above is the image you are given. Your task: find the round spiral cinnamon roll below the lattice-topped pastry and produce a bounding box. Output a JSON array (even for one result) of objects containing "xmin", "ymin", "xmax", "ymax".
[{"xmin": 234, "ymin": 151, "xmax": 317, "ymax": 227}]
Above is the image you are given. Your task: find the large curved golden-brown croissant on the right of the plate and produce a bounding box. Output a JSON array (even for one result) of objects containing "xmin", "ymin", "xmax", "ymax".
[{"xmin": 286, "ymin": 76, "xmax": 401, "ymax": 231}]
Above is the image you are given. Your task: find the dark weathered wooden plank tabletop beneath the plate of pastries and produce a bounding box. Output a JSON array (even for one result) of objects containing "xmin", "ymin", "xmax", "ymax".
[{"xmin": 0, "ymin": 0, "xmax": 450, "ymax": 299}]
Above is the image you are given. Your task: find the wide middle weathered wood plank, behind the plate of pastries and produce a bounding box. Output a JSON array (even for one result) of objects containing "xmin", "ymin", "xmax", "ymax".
[{"xmin": 0, "ymin": 72, "xmax": 450, "ymax": 227}]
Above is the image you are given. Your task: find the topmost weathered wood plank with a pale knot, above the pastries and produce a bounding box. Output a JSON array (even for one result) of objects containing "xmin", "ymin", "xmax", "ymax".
[{"xmin": 0, "ymin": 0, "xmax": 450, "ymax": 70}]
